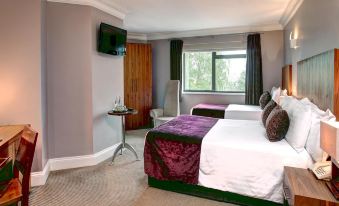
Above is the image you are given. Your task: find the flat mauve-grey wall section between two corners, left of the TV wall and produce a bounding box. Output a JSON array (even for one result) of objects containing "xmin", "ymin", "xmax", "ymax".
[{"xmin": 46, "ymin": 2, "xmax": 93, "ymax": 158}]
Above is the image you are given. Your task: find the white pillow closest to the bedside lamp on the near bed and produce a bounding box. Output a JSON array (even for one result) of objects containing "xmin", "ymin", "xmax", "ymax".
[{"xmin": 300, "ymin": 98, "xmax": 336, "ymax": 162}]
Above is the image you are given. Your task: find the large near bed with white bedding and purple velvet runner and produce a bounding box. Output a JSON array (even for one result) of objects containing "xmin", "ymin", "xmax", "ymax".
[{"xmin": 144, "ymin": 115, "xmax": 313, "ymax": 205}]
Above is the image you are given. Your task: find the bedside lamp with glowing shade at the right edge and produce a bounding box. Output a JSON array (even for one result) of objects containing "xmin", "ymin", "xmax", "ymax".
[{"xmin": 320, "ymin": 121, "xmax": 339, "ymax": 199}]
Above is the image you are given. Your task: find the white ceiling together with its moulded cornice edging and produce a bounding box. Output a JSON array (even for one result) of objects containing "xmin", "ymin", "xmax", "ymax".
[{"xmin": 47, "ymin": 0, "xmax": 303, "ymax": 40}]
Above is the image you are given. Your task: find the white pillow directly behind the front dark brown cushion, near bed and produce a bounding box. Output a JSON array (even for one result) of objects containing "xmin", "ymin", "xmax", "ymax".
[{"xmin": 283, "ymin": 98, "xmax": 312, "ymax": 152}]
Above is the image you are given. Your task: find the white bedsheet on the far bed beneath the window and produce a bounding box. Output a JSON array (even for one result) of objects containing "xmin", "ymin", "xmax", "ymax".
[{"xmin": 225, "ymin": 104, "xmax": 262, "ymax": 120}]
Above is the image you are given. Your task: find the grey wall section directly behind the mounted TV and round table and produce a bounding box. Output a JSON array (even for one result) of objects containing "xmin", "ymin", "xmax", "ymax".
[{"xmin": 91, "ymin": 8, "xmax": 124, "ymax": 152}]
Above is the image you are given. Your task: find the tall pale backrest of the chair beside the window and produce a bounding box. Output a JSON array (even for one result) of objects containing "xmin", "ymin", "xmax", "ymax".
[{"xmin": 164, "ymin": 80, "xmax": 180, "ymax": 117}]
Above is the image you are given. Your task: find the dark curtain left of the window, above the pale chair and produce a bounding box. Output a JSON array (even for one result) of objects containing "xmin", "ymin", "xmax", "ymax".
[{"xmin": 170, "ymin": 40, "xmax": 184, "ymax": 80}]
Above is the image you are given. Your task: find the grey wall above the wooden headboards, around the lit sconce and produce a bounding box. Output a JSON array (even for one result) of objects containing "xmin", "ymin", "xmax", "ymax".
[{"xmin": 284, "ymin": 0, "xmax": 339, "ymax": 94}]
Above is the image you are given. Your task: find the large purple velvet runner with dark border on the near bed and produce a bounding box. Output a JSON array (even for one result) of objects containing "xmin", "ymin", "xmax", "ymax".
[{"xmin": 144, "ymin": 115, "xmax": 218, "ymax": 184}]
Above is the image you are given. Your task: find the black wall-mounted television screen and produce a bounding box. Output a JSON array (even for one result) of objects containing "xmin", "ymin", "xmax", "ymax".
[{"xmin": 98, "ymin": 23, "xmax": 127, "ymax": 56}]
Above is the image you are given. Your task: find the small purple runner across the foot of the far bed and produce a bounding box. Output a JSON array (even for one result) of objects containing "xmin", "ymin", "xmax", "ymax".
[{"xmin": 192, "ymin": 104, "xmax": 228, "ymax": 119}]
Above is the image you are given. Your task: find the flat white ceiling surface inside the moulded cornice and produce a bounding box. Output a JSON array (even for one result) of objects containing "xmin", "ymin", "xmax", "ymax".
[{"xmin": 100, "ymin": 0, "xmax": 298, "ymax": 34}]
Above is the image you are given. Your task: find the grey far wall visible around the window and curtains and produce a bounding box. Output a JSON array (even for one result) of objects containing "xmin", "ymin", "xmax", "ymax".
[{"xmin": 151, "ymin": 31, "xmax": 284, "ymax": 114}]
